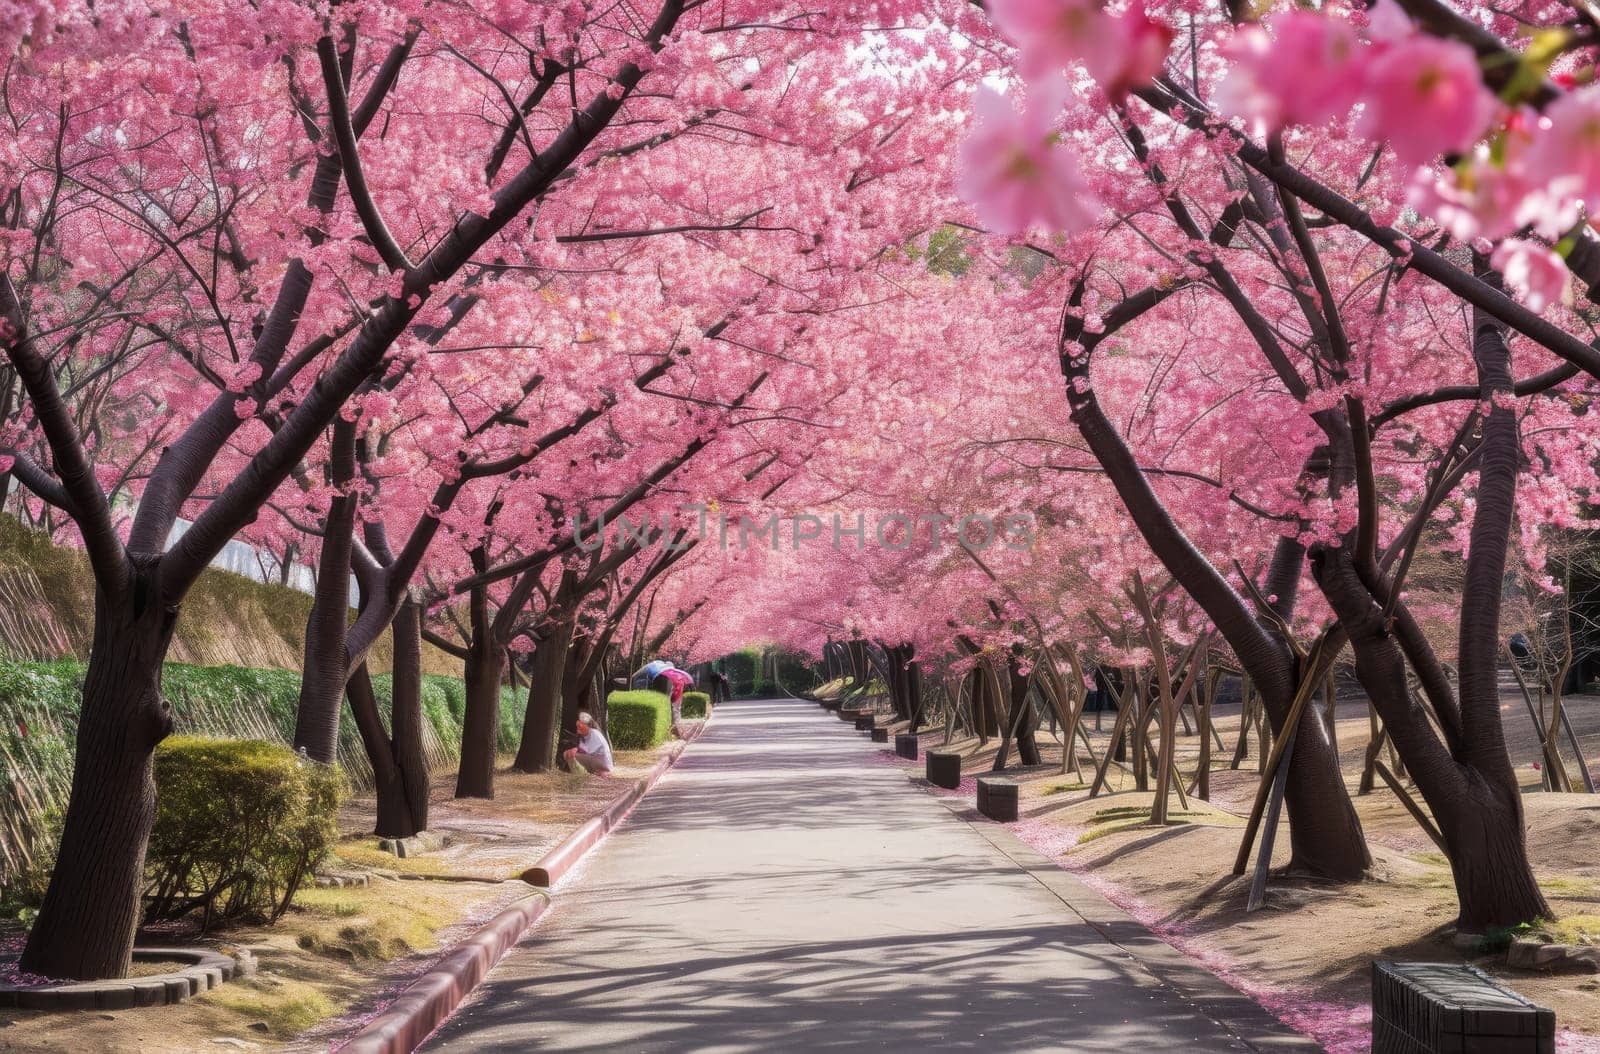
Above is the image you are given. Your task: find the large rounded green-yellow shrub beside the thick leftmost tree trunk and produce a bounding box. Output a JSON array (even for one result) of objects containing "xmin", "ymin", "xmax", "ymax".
[{"xmin": 146, "ymin": 736, "xmax": 344, "ymax": 929}]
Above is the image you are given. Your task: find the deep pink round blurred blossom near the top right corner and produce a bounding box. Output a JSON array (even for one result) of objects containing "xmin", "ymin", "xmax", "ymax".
[{"xmin": 1362, "ymin": 35, "xmax": 1496, "ymax": 165}]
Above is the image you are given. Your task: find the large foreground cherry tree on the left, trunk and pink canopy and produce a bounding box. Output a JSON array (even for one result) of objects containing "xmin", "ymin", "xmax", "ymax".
[{"xmin": 0, "ymin": 0, "xmax": 979, "ymax": 977}]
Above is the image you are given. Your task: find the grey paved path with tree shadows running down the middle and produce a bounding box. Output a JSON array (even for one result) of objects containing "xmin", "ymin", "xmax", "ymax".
[{"xmin": 424, "ymin": 701, "xmax": 1318, "ymax": 1054}]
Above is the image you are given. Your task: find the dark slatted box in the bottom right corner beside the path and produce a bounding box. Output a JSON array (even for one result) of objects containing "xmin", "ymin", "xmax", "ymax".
[{"xmin": 1373, "ymin": 963, "xmax": 1555, "ymax": 1054}]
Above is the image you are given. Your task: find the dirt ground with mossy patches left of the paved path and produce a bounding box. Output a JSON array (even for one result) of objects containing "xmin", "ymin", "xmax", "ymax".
[{"xmin": 0, "ymin": 729, "xmax": 694, "ymax": 1054}]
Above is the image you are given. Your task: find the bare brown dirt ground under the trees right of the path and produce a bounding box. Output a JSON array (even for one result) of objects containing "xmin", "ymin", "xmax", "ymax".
[{"xmin": 885, "ymin": 696, "xmax": 1600, "ymax": 1052}]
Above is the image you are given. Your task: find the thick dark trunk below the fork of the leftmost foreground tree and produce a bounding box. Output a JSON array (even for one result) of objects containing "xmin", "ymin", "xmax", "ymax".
[{"xmin": 21, "ymin": 575, "xmax": 178, "ymax": 980}]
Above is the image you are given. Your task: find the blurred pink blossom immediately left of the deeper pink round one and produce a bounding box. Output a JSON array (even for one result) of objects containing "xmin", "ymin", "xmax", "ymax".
[{"xmin": 1216, "ymin": 11, "xmax": 1362, "ymax": 131}]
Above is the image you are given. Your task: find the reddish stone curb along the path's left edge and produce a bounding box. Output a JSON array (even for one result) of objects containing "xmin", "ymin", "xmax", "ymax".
[{"xmin": 333, "ymin": 715, "xmax": 710, "ymax": 1054}]
